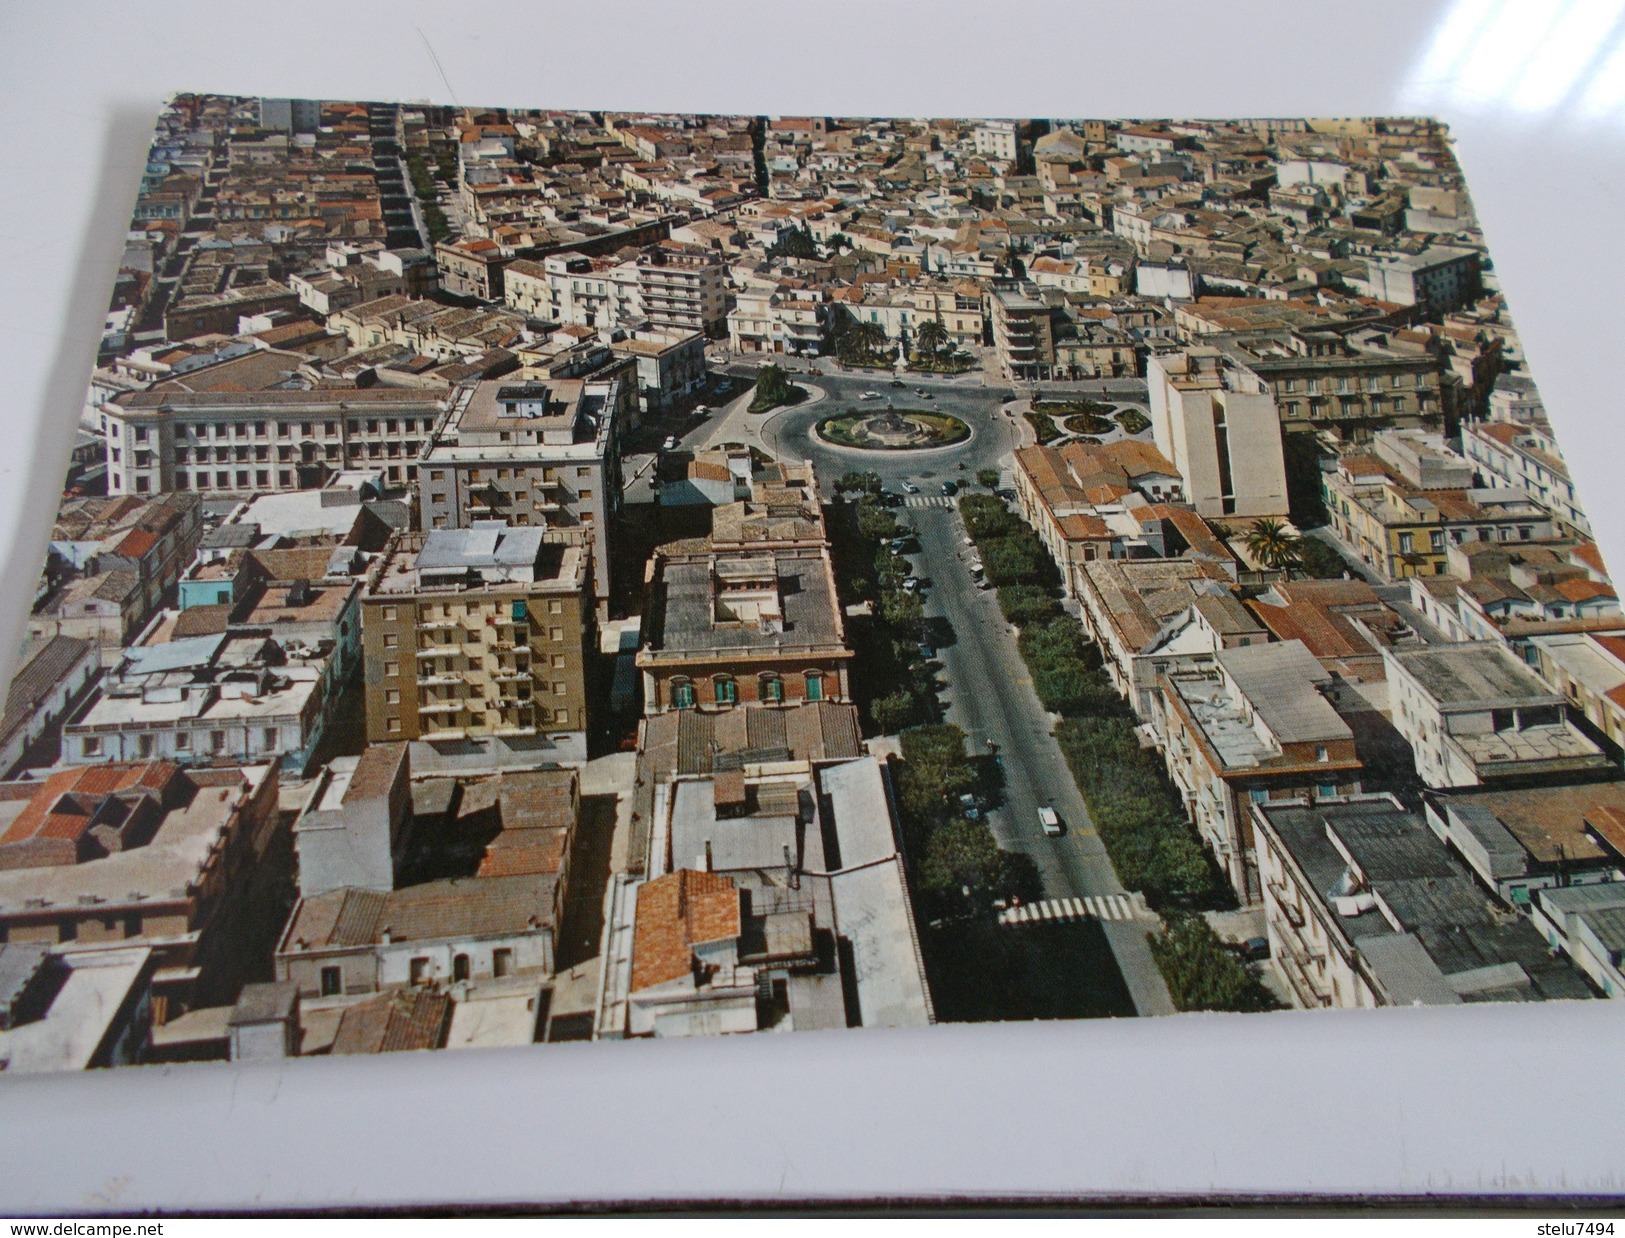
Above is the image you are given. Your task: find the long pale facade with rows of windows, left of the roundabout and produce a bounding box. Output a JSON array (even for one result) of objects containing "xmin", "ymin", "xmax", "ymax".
[{"xmin": 99, "ymin": 387, "xmax": 444, "ymax": 496}]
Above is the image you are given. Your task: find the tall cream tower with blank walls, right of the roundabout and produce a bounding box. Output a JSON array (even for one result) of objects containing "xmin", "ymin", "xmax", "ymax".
[{"xmin": 1146, "ymin": 348, "xmax": 1289, "ymax": 518}]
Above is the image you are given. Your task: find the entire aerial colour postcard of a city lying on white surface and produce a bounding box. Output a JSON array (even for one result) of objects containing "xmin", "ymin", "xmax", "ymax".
[{"xmin": 0, "ymin": 94, "xmax": 1625, "ymax": 1065}]
